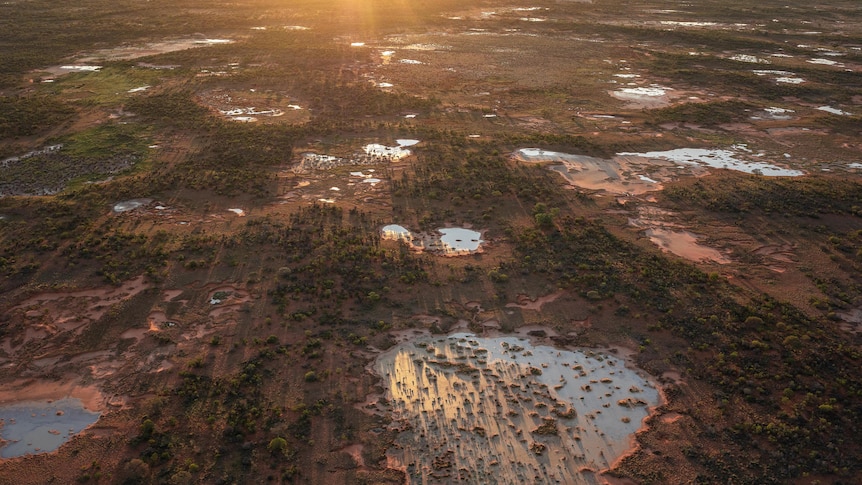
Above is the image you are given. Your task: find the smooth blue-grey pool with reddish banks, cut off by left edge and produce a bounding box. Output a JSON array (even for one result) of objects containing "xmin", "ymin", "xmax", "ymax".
[{"xmin": 0, "ymin": 398, "xmax": 100, "ymax": 458}]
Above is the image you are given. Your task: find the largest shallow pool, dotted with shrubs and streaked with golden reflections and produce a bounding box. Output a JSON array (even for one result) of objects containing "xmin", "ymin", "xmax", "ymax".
[{"xmin": 372, "ymin": 333, "xmax": 659, "ymax": 484}]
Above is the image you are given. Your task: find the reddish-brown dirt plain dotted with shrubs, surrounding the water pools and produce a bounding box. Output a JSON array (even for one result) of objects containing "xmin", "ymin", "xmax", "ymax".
[{"xmin": 0, "ymin": 0, "xmax": 862, "ymax": 484}]
